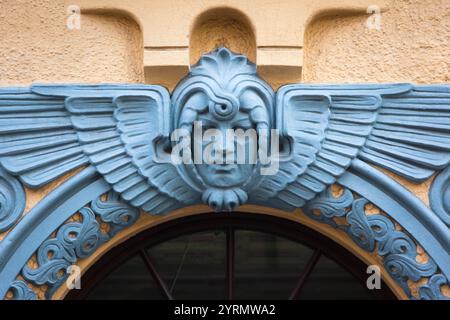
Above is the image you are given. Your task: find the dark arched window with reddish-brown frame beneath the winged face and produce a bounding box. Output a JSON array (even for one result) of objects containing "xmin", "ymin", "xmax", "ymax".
[{"xmin": 66, "ymin": 212, "xmax": 395, "ymax": 299}]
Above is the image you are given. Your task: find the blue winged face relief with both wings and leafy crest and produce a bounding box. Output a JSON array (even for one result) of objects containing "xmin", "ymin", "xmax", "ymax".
[{"xmin": 0, "ymin": 48, "xmax": 450, "ymax": 214}]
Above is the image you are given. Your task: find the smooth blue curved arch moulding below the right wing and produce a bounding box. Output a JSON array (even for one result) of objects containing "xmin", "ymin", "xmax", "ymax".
[{"xmin": 338, "ymin": 160, "xmax": 450, "ymax": 299}]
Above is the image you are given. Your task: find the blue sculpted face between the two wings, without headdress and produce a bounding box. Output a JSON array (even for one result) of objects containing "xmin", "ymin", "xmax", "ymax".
[{"xmin": 192, "ymin": 111, "xmax": 256, "ymax": 188}]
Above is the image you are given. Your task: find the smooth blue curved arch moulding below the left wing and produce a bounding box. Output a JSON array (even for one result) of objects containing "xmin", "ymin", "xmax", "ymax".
[{"xmin": 0, "ymin": 167, "xmax": 110, "ymax": 299}]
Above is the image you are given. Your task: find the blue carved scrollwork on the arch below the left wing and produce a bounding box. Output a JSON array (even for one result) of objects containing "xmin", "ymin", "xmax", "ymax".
[{"xmin": 22, "ymin": 192, "xmax": 139, "ymax": 298}]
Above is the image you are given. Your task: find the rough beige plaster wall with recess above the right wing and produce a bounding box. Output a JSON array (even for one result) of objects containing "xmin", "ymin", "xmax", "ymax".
[{"xmin": 303, "ymin": 0, "xmax": 450, "ymax": 83}]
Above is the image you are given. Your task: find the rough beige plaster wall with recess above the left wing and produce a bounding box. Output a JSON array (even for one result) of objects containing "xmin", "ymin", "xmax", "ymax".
[{"xmin": 0, "ymin": 0, "xmax": 144, "ymax": 85}]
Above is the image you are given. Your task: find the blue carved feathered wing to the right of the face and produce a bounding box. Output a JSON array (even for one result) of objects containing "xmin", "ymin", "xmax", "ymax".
[{"xmin": 253, "ymin": 84, "xmax": 450, "ymax": 209}]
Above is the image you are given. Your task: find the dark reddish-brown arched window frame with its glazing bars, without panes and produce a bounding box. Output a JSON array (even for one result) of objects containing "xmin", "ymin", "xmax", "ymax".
[{"xmin": 64, "ymin": 211, "xmax": 396, "ymax": 300}]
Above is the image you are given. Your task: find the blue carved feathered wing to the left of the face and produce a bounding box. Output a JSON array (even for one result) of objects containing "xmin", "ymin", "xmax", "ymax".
[{"xmin": 0, "ymin": 85, "xmax": 199, "ymax": 214}]
